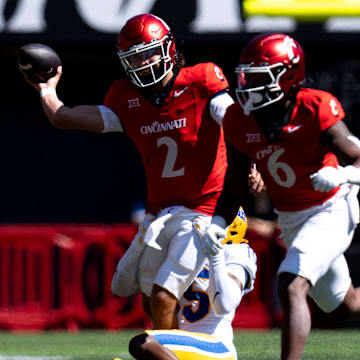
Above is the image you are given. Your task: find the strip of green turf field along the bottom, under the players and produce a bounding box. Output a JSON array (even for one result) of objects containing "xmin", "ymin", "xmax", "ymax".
[{"xmin": 0, "ymin": 329, "xmax": 360, "ymax": 360}]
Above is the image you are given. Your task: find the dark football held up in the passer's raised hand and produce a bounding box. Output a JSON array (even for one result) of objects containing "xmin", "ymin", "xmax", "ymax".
[{"xmin": 17, "ymin": 43, "xmax": 61, "ymax": 83}]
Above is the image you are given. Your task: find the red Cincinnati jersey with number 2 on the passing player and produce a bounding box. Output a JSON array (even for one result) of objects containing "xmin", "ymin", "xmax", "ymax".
[{"xmin": 104, "ymin": 63, "xmax": 228, "ymax": 215}]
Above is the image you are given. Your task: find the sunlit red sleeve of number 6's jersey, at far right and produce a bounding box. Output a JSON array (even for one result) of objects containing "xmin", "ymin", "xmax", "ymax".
[{"xmin": 318, "ymin": 92, "xmax": 345, "ymax": 131}]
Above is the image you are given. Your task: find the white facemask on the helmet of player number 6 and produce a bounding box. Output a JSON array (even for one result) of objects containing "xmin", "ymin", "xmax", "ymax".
[{"xmin": 235, "ymin": 63, "xmax": 287, "ymax": 115}]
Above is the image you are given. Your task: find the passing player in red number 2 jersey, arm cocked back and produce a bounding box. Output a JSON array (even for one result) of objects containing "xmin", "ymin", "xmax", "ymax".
[{"xmin": 22, "ymin": 14, "xmax": 261, "ymax": 329}]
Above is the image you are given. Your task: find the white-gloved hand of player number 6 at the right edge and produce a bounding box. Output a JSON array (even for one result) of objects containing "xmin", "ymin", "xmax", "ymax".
[{"xmin": 310, "ymin": 165, "xmax": 360, "ymax": 192}]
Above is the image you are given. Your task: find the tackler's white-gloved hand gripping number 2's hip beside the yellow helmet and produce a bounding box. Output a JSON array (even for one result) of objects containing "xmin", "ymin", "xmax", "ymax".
[{"xmin": 194, "ymin": 216, "xmax": 226, "ymax": 257}]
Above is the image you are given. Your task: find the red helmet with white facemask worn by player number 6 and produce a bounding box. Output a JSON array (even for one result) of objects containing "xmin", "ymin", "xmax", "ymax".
[{"xmin": 235, "ymin": 34, "xmax": 305, "ymax": 115}]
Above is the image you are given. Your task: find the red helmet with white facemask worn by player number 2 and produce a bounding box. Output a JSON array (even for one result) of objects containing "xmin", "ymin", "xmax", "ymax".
[{"xmin": 118, "ymin": 14, "xmax": 177, "ymax": 87}]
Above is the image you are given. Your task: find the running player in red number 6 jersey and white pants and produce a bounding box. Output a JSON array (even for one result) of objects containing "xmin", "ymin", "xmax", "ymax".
[{"xmin": 201, "ymin": 34, "xmax": 360, "ymax": 360}]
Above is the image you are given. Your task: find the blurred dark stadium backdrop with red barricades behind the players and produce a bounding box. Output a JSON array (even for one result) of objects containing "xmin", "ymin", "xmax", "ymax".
[{"xmin": 0, "ymin": 0, "xmax": 360, "ymax": 329}]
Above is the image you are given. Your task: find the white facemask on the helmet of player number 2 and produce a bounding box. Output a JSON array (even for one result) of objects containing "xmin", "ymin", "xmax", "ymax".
[{"xmin": 118, "ymin": 35, "xmax": 174, "ymax": 87}]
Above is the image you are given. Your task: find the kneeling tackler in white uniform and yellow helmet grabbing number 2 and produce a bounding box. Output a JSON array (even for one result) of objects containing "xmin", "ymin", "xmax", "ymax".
[{"xmin": 112, "ymin": 208, "xmax": 256, "ymax": 360}]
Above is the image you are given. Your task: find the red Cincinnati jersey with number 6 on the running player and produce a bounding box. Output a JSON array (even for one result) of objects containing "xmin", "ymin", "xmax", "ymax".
[{"xmin": 223, "ymin": 88, "xmax": 345, "ymax": 211}]
